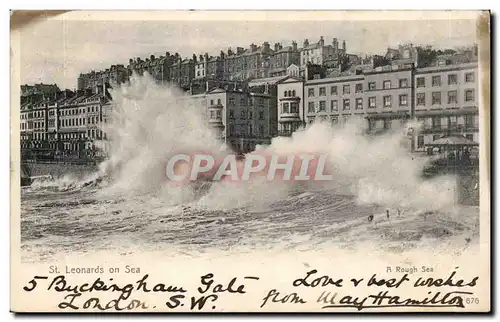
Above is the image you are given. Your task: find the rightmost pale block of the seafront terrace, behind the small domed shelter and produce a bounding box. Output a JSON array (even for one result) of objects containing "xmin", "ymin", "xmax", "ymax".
[{"xmin": 414, "ymin": 63, "xmax": 479, "ymax": 151}]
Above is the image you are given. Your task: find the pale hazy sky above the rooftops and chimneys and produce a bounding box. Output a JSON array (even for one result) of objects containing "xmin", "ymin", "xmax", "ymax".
[{"xmin": 16, "ymin": 12, "xmax": 476, "ymax": 89}]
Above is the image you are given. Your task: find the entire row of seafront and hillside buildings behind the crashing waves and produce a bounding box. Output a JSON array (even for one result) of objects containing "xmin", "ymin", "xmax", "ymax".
[{"xmin": 21, "ymin": 37, "xmax": 479, "ymax": 157}]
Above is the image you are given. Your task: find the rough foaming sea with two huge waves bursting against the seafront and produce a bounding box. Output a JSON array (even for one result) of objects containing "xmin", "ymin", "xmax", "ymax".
[{"xmin": 21, "ymin": 75, "xmax": 479, "ymax": 262}]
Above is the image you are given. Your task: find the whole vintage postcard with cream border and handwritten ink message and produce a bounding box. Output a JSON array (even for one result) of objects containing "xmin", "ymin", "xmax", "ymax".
[{"xmin": 10, "ymin": 10, "xmax": 491, "ymax": 314}]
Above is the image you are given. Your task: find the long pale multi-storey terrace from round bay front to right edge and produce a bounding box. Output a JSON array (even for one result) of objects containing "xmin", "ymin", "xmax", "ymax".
[{"xmin": 278, "ymin": 60, "xmax": 479, "ymax": 151}]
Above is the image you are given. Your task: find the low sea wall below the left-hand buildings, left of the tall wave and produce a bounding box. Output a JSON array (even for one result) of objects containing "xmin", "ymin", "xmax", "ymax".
[{"xmin": 24, "ymin": 163, "xmax": 98, "ymax": 178}]
